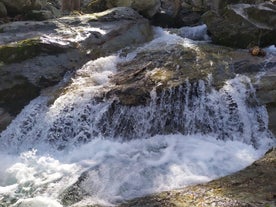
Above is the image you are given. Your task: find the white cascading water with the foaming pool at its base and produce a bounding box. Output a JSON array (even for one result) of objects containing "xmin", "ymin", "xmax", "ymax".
[{"xmin": 0, "ymin": 27, "xmax": 275, "ymax": 207}]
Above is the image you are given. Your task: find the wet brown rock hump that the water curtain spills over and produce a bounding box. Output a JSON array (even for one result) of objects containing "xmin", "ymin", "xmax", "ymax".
[{"xmin": 108, "ymin": 43, "xmax": 264, "ymax": 105}]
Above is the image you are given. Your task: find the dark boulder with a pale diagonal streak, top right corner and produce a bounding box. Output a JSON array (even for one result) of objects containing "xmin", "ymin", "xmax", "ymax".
[{"xmin": 203, "ymin": 2, "xmax": 276, "ymax": 48}]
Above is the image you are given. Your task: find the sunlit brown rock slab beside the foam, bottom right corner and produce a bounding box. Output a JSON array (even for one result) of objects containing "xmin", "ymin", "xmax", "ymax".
[{"xmin": 120, "ymin": 148, "xmax": 276, "ymax": 207}]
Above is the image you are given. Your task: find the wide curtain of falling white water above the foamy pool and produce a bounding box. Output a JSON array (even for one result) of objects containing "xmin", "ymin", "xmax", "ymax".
[{"xmin": 1, "ymin": 72, "xmax": 271, "ymax": 151}]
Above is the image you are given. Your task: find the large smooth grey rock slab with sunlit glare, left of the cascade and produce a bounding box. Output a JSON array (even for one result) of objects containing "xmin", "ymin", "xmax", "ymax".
[{"xmin": 0, "ymin": 8, "xmax": 152, "ymax": 132}]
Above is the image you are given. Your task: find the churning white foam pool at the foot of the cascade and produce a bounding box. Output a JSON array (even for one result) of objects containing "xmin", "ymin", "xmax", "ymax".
[{"xmin": 0, "ymin": 134, "xmax": 265, "ymax": 207}]
